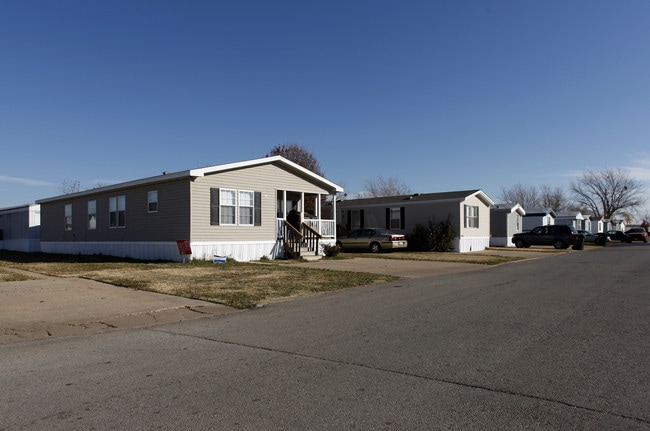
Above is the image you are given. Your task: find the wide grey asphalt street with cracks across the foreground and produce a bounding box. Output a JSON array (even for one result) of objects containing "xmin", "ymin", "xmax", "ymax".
[{"xmin": 0, "ymin": 243, "xmax": 650, "ymax": 430}]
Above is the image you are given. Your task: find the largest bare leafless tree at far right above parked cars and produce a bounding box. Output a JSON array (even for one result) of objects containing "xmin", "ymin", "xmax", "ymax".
[{"xmin": 571, "ymin": 168, "xmax": 644, "ymax": 219}]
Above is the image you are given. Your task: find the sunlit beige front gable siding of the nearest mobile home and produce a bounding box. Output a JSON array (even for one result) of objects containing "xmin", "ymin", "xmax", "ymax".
[{"xmin": 191, "ymin": 164, "xmax": 328, "ymax": 242}]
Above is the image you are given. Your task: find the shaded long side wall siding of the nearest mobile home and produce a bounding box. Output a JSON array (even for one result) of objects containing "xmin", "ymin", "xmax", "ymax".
[{"xmin": 41, "ymin": 180, "xmax": 189, "ymax": 242}]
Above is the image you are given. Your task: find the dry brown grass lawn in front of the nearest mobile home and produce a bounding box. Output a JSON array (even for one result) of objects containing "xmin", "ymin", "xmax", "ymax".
[{"xmin": 0, "ymin": 252, "xmax": 396, "ymax": 308}]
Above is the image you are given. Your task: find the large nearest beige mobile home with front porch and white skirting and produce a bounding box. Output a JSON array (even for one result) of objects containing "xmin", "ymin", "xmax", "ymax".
[{"xmin": 38, "ymin": 156, "xmax": 343, "ymax": 261}]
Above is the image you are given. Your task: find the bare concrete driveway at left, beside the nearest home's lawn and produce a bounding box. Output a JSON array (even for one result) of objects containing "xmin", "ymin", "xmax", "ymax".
[{"xmin": 0, "ymin": 268, "xmax": 239, "ymax": 343}]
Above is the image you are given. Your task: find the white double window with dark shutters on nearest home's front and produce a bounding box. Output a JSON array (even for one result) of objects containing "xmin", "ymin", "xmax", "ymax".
[{"xmin": 210, "ymin": 189, "xmax": 262, "ymax": 226}]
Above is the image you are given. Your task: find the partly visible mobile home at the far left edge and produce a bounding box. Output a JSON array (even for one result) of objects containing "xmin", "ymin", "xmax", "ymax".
[{"xmin": 0, "ymin": 204, "xmax": 41, "ymax": 252}]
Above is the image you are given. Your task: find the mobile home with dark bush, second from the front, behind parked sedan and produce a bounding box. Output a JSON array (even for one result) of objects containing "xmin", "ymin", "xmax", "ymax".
[{"xmin": 337, "ymin": 190, "xmax": 494, "ymax": 252}]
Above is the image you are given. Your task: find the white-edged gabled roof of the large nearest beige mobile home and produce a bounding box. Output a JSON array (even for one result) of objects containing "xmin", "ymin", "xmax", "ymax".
[{"xmin": 36, "ymin": 156, "xmax": 343, "ymax": 204}]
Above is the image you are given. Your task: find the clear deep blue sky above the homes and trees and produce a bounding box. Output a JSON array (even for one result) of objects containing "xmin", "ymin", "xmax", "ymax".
[{"xmin": 0, "ymin": 0, "xmax": 650, "ymax": 218}]
